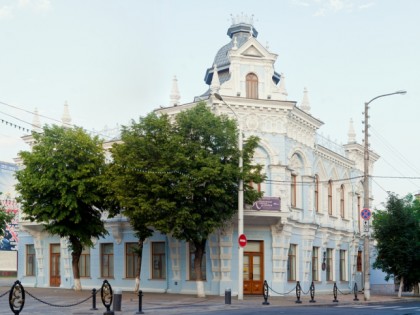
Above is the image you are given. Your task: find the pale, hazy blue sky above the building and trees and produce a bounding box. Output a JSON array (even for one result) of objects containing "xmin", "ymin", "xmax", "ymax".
[{"xmin": 0, "ymin": 0, "xmax": 420, "ymax": 207}]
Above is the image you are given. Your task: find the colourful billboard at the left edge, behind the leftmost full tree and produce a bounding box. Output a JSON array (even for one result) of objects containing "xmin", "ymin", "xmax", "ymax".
[{"xmin": 0, "ymin": 162, "xmax": 19, "ymax": 250}]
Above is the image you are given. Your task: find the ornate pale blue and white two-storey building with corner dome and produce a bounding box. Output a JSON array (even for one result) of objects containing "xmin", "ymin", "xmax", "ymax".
[{"xmin": 19, "ymin": 16, "xmax": 378, "ymax": 295}]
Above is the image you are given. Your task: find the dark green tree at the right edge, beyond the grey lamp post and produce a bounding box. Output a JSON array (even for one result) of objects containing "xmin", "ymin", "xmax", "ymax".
[{"xmin": 373, "ymin": 194, "xmax": 420, "ymax": 295}]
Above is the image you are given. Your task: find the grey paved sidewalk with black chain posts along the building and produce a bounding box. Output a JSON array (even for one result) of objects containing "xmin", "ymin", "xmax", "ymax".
[{"xmin": 0, "ymin": 286, "xmax": 420, "ymax": 315}]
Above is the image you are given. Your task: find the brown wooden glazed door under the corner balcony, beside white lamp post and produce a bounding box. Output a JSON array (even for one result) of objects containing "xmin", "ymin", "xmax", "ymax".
[{"xmin": 244, "ymin": 241, "xmax": 264, "ymax": 294}]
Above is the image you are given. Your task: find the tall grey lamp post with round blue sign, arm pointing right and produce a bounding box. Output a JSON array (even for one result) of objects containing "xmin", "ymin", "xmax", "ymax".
[{"xmin": 359, "ymin": 91, "xmax": 407, "ymax": 301}]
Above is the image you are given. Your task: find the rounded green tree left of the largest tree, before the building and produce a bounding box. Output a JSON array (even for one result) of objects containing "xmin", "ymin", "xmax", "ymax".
[{"xmin": 16, "ymin": 126, "xmax": 107, "ymax": 290}]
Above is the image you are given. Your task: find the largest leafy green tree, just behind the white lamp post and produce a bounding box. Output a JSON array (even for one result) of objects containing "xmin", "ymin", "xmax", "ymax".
[{"xmin": 109, "ymin": 103, "xmax": 264, "ymax": 295}]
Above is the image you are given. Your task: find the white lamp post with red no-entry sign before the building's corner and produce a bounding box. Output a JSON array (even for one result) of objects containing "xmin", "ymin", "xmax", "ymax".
[{"xmin": 213, "ymin": 93, "xmax": 244, "ymax": 300}]
